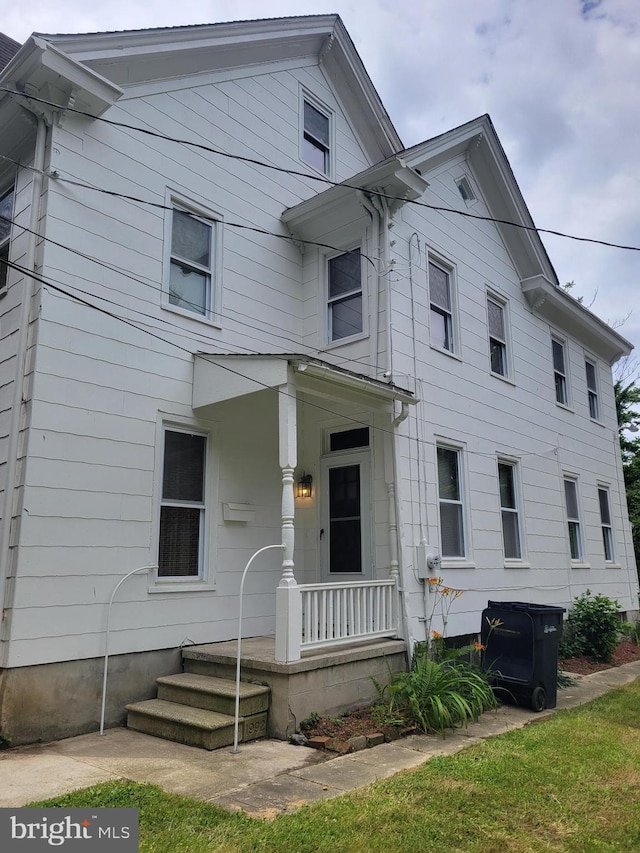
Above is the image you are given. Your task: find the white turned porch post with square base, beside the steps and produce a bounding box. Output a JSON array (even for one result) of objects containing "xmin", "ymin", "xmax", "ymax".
[{"xmin": 276, "ymin": 376, "xmax": 302, "ymax": 663}]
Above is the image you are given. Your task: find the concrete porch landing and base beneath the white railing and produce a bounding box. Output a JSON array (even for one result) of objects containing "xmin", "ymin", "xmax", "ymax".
[{"xmin": 182, "ymin": 637, "xmax": 407, "ymax": 740}]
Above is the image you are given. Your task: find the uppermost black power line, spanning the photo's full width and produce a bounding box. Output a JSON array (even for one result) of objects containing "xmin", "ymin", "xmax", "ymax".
[{"xmin": 0, "ymin": 86, "xmax": 640, "ymax": 252}]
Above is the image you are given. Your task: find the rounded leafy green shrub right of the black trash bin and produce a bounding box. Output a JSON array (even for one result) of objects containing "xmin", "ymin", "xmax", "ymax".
[{"xmin": 560, "ymin": 590, "xmax": 620, "ymax": 661}]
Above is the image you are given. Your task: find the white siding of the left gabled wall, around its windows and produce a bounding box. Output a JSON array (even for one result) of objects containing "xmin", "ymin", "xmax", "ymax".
[{"xmin": 5, "ymin": 67, "xmax": 369, "ymax": 666}]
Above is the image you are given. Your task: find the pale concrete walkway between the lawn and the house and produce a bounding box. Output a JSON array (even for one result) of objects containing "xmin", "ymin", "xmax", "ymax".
[{"xmin": 0, "ymin": 661, "xmax": 640, "ymax": 818}]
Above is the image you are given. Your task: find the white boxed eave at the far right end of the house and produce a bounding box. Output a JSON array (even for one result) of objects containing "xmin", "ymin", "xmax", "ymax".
[{"xmin": 520, "ymin": 275, "xmax": 633, "ymax": 364}]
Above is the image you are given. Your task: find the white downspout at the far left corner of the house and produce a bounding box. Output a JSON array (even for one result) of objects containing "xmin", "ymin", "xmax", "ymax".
[{"xmin": 0, "ymin": 117, "xmax": 47, "ymax": 667}]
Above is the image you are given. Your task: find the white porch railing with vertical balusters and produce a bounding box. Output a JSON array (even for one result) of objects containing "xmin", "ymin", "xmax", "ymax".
[{"xmin": 298, "ymin": 578, "xmax": 398, "ymax": 651}]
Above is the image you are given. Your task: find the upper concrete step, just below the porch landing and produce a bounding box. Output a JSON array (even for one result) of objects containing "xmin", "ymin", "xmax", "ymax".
[{"xmin": 157, "ymin": 672, "xmax": 270, "ymax": 717}]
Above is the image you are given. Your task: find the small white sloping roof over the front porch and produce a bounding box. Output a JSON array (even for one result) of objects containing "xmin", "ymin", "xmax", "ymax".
[{"xmin": 192, "ymin": 352, "xmax": 418, "ymax": 409}]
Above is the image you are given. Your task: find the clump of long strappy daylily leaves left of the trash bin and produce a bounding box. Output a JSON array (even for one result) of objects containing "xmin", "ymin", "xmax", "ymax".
[{"xmin": 378, "ymin": 648, "xmax": 497, "ymax": 732}]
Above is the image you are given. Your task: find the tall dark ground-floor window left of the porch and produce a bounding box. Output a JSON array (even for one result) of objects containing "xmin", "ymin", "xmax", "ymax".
[{"xmin": 158, "ymin": 429, "xmax": 207, "ymax": 578}]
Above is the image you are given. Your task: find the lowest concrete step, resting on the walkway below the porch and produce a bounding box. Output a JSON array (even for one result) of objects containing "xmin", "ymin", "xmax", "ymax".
[{"xmin": 127, "ymin": 699, "xmax": 267, "ymax": 750}]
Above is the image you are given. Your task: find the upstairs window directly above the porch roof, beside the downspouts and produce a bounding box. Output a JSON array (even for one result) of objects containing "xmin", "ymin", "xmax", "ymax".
[{"xmin": 327, "ymin": 249, "xmax": 363, "ymax": 341}]
